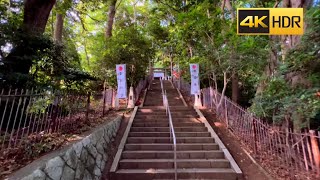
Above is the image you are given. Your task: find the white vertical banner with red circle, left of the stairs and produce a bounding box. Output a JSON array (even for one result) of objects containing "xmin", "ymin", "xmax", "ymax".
[{"xmin": 116, "ymin": 64, "xmax": 127, "ymax": 99}]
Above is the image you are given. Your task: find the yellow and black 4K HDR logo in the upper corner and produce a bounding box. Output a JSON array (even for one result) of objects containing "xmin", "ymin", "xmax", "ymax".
[{"xmin": 237, "ymin": 8, "xmax": 303, "ymax": 35}]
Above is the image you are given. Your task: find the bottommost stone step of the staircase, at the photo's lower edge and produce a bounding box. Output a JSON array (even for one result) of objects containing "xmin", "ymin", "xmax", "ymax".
[{"xmin": 112, "ymin": 168, "xmax": 237, "ymax": 180}]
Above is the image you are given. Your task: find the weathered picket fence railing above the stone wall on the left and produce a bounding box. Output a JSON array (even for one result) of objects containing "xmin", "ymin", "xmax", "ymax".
[{"xmin": 0, "ymin": 78, "xmax": 149, "ymax": 151}]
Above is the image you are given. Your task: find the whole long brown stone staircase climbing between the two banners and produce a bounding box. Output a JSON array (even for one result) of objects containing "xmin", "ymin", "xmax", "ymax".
[{"xmin": 110, "ymin": 80, "xmax": 241, "ymax": 180}]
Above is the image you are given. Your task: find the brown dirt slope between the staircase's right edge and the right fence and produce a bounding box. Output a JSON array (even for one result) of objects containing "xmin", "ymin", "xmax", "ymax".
[{"xmin": 201, "ymin": 110, "xmax": 275, "ymax": 180}]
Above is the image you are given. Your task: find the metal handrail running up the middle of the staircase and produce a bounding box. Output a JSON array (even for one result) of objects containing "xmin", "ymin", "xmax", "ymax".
[{"xmin": 160, "ymin": 80, "xmax": 178, "ymax": 180}]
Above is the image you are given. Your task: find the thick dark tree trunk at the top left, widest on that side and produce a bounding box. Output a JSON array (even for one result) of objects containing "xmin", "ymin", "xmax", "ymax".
[{"xmin": 23, "ymin": 0, "xmax": 56, "ymax": 34}]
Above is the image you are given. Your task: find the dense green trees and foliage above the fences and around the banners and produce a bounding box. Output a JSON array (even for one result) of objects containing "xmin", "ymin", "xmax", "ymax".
[{"xmin": 0, "ymin": 0, "xmax": 320, "ymax": 131}]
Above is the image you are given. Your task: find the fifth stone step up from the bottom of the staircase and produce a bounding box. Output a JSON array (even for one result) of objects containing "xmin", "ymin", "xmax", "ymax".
[{"xmin": 127, "ymin": 137, "xmax": 215, "ymax": 144}]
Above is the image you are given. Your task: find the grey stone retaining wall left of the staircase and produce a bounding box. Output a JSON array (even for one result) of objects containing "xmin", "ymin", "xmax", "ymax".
[{"xmin": 22, "ymin": 116, "xmax": 122, "ymax": 180}]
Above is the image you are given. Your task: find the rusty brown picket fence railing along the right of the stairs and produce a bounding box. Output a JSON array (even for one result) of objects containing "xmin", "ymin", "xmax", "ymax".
[{"xmin": 176, "ymin": 79, "xmax": 320, "ymax": 177}]
